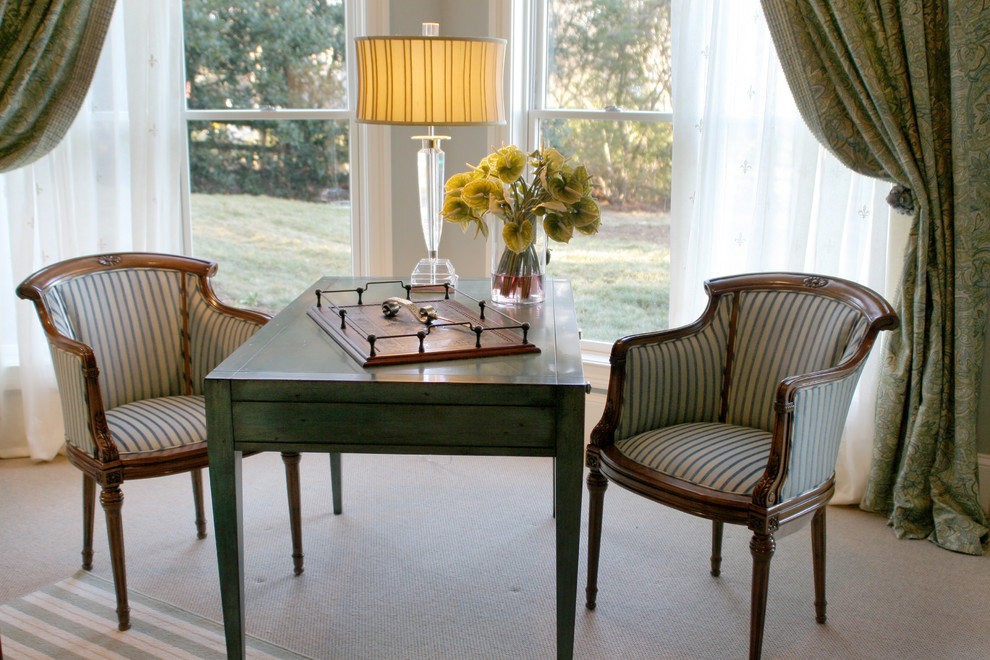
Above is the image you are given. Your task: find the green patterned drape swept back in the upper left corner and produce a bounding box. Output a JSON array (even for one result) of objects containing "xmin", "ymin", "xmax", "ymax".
[{"xmin": 0, "ymin": 0, "xmax": 114, "ymax": 172}]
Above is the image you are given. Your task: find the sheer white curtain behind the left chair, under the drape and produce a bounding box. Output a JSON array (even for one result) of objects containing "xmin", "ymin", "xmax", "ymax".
[{"xmin": 0, "ymin": 0, "xmax": 184, "ymax": 460}]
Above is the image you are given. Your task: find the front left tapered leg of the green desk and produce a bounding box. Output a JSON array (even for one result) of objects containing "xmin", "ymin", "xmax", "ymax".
[{"xmin": 206, "ymin": 379, "xmax": 245, "ymax": 660}]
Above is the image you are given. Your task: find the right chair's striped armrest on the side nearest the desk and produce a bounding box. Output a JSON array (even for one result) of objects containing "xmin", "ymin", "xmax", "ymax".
[{"xmin": 591, "ymin": 301, "xmax": 730, "ymax": 447}]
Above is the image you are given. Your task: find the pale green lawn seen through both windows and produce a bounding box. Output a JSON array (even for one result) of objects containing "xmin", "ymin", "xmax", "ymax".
[{"xmin": 192, "ymin": 194, "xmax": 670, "ymax": 342}]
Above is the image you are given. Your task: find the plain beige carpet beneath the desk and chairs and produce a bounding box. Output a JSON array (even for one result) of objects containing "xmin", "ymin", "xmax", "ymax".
[{"xmin": 0, "ymin": 454, "xmax": 990, "ymax": 660}]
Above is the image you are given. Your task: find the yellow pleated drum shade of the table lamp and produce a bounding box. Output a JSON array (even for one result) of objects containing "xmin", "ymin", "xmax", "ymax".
[{"xmin": 355, "ymin": 37, "xmax": 505, "ymax": 126}]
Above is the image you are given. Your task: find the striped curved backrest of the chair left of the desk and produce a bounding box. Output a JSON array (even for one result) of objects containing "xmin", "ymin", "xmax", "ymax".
[{"xmin": 17, "ymin": 253, "xmax": 267, "ymax": 447}]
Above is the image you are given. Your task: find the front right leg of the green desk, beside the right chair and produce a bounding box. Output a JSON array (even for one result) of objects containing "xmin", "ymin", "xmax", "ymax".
[{"xmin": 554, "ymin": 388, "xmax": 584, "ymax": 660}]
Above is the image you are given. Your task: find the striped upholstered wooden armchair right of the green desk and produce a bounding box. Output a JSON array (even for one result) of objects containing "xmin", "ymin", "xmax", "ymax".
[{"xmin": 587, "ymin": 273, "xmax": 898, "ymax": 658}]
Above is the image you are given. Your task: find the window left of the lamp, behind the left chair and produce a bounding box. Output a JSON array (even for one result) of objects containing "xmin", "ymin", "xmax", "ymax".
[{"xmin": 183, "ymin": 0, "xmax": 352, "ymax": 312}]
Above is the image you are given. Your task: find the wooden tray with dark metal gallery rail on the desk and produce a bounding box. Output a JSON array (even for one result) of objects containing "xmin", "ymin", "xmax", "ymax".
[{"xmin": 309, "ymin": 298, "xmax": 540, "ymax": 367}]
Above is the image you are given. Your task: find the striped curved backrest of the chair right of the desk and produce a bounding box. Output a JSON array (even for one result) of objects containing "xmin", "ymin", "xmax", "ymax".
[{"xmin": 611, "ymin": 273, "xmax": 897, "ymax": 439}]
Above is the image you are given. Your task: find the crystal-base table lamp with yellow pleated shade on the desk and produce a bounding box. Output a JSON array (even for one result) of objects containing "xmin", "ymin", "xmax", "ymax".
[{"xmin": 355, "ymin": 23, "xmax": 505, "ymax": 285}]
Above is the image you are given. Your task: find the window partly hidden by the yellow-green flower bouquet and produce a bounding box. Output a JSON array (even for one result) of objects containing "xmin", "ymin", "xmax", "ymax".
[{"xmin": 529, "ymin": 0, "xmax": 673, "ymax": 343}]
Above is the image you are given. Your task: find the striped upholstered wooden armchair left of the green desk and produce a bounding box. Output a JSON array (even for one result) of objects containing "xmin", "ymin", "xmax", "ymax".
[{"xmin": 17, "ymin": 253, "xmax": 339, "ymax": 630}]
